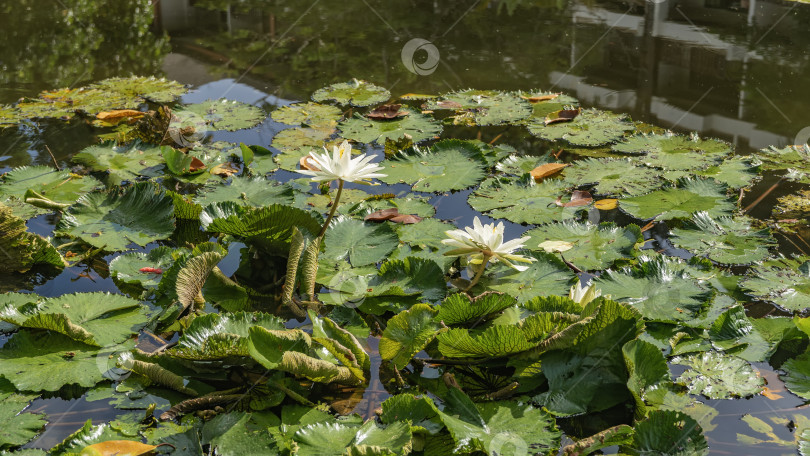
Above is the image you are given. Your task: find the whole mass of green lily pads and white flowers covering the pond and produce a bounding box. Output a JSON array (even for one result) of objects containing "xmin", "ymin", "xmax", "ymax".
[{"xmin": 0, "ymin": 77, "xmax": 810, "ymax": 455}]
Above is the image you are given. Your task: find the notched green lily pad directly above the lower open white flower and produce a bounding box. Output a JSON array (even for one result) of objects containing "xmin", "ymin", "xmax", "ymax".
[{"xmin": 467, "ymin": 177, "xmax": 582, "ymax": 224}]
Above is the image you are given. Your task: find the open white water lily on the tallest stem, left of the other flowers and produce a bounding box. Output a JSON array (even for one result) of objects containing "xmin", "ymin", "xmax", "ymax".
[{"xmin": 298, "ymin": 141, "xmax": 386, "ymax": 184}]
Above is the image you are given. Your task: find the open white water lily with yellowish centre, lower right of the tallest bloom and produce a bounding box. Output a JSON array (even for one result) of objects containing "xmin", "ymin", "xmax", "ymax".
[{"xmin": 442, "ymin": 217, "xmax": 535, "ymax": 271}]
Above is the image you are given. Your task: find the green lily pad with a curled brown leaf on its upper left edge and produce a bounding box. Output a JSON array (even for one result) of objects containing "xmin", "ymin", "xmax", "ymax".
[{"xmin": 528, "ymin": 109, "xmax": 635, "ymax": 147}]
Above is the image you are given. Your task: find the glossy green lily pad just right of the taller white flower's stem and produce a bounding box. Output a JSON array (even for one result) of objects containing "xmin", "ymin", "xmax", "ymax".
[{"xmin": 323, "ymin": 219, "xmax": 399, "ymax": 267}]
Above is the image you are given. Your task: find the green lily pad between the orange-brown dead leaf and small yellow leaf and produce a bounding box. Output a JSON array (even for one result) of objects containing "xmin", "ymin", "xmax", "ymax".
[{"xmin": 564, "ymin": 158, "xmax": 661, "ymax": 196}]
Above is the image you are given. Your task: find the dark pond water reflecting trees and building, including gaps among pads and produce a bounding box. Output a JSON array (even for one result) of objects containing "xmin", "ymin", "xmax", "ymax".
[{"xmin": 0, "ymin": 0, "xmax": 810, "ymax": 455}]
